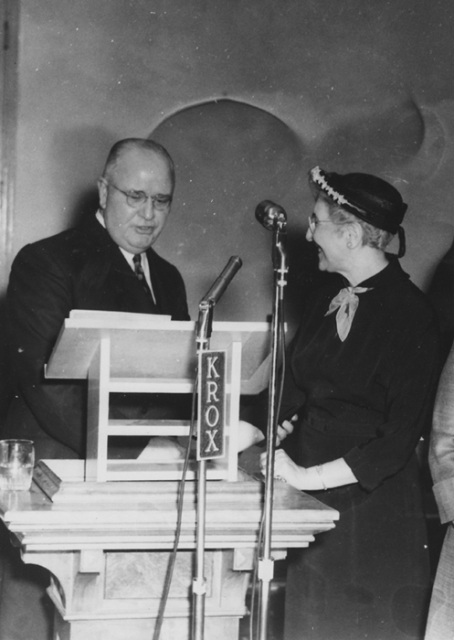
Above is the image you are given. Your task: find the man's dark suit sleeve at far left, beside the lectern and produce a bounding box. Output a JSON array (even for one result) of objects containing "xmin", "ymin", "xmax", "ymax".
[{"xmin": 8, "ymin": 244, "xmax": 85, "ymax": 455}]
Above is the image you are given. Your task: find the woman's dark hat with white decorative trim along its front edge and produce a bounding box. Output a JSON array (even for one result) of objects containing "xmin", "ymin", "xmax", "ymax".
[{"xmin": 309, "ymin": 167, "xmax": 407, "ymax": 234}]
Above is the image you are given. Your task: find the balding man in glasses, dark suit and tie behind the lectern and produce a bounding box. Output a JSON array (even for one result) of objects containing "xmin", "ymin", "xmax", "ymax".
[{"xmin": 1, "ymin": 138, "xmax": 189, "ymax": 460}]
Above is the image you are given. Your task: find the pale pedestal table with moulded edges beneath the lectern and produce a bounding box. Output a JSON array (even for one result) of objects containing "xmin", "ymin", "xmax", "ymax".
[{"xmin": 0, "ymin": 460, "xmax": 338, "ymax": 640}]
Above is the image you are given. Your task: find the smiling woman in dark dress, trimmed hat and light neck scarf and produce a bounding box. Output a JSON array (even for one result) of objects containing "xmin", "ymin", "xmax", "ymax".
[{"xmin": 252, "ymin": 167, "xmax": 438, "ymax": 640}]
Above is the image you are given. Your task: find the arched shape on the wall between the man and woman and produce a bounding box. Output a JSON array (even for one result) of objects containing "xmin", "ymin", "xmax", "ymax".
[{"xmin": 150, "ymin": 100, "xmax": 312, "ymax": 330}]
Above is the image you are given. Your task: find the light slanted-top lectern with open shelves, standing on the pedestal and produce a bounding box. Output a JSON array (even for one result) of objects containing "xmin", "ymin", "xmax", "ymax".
[{"xmin": 46, "ymin": 311, "xmax": 270, "ymax": 482}]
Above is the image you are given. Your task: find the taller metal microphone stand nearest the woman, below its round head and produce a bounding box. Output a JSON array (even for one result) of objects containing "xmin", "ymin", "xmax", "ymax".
[{"xmin": 258, "ymin": 219, "xmax": 288, "ymax": 640}]
